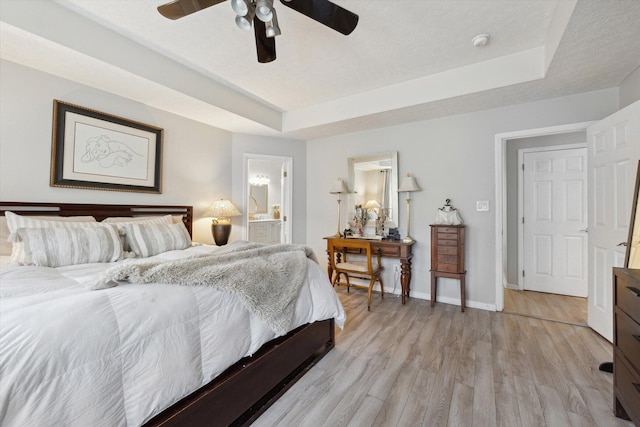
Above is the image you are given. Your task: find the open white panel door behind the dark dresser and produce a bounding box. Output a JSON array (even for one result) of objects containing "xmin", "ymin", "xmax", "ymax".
[{"xmin": 587, "ymin": 101, "xmax": 640, "ymax": 341}]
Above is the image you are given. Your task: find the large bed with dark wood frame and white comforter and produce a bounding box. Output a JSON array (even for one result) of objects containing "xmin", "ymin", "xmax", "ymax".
[{"xmin": 0, "ymin": 202, "xmax": 345, "ymax": 426}]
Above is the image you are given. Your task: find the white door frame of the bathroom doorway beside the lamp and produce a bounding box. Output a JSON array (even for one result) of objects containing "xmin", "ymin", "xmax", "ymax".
[{"xmin": 242, "ymin": 153, "xmax": 293, "ymax": 243}]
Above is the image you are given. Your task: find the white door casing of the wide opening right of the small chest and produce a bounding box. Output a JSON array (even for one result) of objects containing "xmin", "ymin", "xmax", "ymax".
[{"xmin": 495, "ymin": 121, "xmax": 596, "ymax": 311}]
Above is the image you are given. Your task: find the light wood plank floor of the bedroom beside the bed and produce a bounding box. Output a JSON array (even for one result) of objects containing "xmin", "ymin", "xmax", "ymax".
[{"xmin": 254, "ymin": 288, "xmax": 632, "ymax": 427}]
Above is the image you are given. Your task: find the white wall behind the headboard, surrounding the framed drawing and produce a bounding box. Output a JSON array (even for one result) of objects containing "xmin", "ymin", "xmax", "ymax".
[{"xmin": 0, "ymin": 60, "xmax": 232, "ymax": 243}]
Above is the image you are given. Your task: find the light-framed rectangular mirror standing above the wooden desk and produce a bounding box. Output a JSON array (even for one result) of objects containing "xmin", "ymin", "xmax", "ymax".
[{"xmin": 346, "ymin": 151, "xmax": 398, "ymax": 229}]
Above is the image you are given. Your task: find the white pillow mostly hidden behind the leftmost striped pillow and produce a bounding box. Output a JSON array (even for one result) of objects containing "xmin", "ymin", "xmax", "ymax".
[{"xmin": 4, "ymin": 211, "xmax": 100, "ymax": 265}]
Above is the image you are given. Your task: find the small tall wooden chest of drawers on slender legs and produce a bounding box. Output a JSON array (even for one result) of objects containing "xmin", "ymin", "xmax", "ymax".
[{"xmin": 431, "ymin": 225, "xmax": 467, "ymax": 311}]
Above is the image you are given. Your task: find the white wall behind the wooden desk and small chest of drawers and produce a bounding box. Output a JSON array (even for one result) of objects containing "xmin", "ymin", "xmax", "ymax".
[{"xmin": 307, "ymin": 88, "xmax": 618, "ymax": 309}]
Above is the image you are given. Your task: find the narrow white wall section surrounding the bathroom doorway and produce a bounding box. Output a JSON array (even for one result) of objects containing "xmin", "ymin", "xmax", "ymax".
[{"xmin": 231, "ymin": 134, "xmax": 308, "ymax": 243}]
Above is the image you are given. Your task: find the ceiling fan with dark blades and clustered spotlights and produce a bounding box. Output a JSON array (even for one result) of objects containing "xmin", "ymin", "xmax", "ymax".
[{"xmin": 158, "ymin": 0, "xmax": 358, "ymax": 63}]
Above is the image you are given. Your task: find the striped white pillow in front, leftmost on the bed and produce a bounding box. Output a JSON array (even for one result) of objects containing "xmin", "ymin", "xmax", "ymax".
[{"xmin": 16, "ymin": 224, "xmax": 123, "ymax": 267}]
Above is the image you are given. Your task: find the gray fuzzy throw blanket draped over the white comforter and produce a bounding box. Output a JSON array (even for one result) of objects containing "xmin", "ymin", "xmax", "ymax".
[{"xmin": 88, "ymin": 241, "xmax": 318, "ymax": 335}]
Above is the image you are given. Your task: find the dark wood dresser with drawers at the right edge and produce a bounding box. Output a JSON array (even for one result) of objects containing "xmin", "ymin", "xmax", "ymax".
[{"xmin": 613, "ymin": 268, "xmax": 640, "ymax": 426}]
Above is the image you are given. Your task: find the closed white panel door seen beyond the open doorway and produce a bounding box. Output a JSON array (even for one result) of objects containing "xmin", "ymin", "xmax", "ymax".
[{"xmin": 523, "ymin": 148, "xmax": 587, "ymax": 297}]
